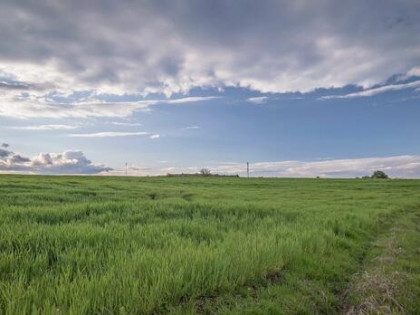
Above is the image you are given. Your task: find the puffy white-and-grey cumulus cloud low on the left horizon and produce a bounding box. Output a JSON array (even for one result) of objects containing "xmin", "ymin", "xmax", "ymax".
[{"xmin": 0, "ymin": 150, "xmax": 112, "ymax": 174}]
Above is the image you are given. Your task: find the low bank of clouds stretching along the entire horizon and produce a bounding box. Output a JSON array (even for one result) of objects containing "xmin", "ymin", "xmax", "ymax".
[{"xmin": 0, "ymin": 148, "xmax": 420, "ymax": 178}]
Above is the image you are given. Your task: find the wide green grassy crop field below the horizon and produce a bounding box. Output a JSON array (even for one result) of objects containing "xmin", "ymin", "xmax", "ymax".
[{"xmin": 0, "ymin": 175, "xmax": 420, "ymax": 314}]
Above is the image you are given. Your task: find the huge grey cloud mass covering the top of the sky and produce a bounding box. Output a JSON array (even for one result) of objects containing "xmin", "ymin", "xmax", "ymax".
[{"xmin": 0, "ymin": 0, "xmax": 420, "ymax": 117}]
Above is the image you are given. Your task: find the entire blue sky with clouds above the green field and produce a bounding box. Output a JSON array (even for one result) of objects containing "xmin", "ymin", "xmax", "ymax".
[{"xmin": 0, "ymin": 0, "xmax": 420, "ymax": 178}]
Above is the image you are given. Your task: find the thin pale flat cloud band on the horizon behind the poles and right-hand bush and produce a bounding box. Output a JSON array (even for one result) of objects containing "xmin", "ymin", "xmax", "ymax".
[{"xmin": 104, "ymin": 155, "xmax": 420, "ymax": 178}]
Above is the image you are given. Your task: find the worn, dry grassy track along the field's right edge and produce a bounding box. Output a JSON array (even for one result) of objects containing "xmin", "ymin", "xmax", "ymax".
[{"xmin": 341, "ymin": 209, "xmax": 420, "ymax": 314}]
